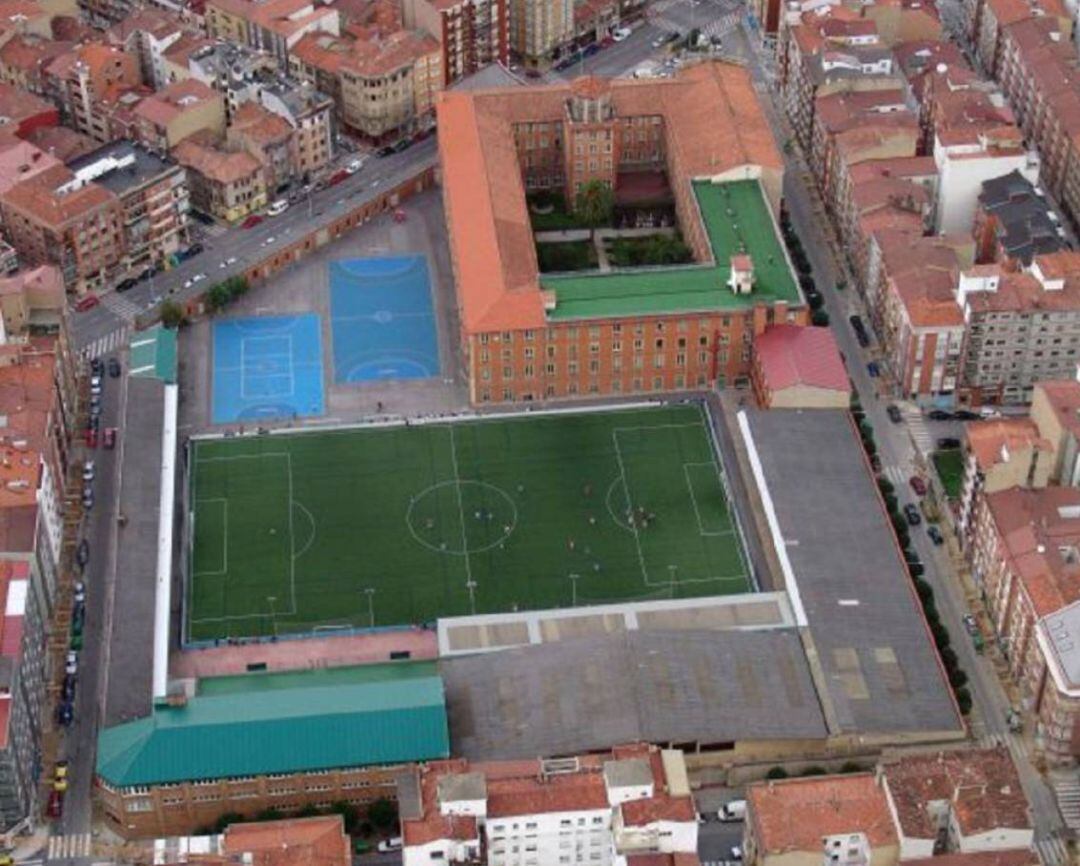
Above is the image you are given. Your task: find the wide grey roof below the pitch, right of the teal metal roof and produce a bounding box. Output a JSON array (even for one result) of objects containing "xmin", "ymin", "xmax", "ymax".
[{"xmin": 438, "ymin": 628, "xmax": 826, "ymax": 760}]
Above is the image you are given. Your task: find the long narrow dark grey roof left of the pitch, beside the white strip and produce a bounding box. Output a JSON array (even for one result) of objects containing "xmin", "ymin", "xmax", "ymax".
[{"xmin": 103, "ymin": 377, "xmax": 165, "ymax": 727}]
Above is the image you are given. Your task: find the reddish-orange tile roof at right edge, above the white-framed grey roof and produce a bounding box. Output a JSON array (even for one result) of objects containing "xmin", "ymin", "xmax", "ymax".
[{"xmin": 986, "ymin": 487, "xmax": 1080, "ymax": 618}]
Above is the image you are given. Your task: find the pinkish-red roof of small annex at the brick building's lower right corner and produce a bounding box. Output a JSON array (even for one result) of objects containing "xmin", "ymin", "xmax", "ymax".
[{"xmin": 754, "ymin": 325, "xmax": 851, "ymax": 393}]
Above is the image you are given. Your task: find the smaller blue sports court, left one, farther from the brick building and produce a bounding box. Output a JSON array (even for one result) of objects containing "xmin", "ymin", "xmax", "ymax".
[{"xmin": 213, "ymin": 313, "xmax": 323, "ymax": 424}]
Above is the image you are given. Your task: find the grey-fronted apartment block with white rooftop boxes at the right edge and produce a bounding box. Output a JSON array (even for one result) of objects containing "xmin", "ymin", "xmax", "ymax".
[{"xmin": 957, "ymin": 252, "xmax": 1080, "ymax": 405}]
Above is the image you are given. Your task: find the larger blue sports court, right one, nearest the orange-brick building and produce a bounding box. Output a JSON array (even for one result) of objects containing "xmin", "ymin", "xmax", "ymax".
[{"xmin": 329, "ymin": 256, "xmax": 438, "ymax": 382}]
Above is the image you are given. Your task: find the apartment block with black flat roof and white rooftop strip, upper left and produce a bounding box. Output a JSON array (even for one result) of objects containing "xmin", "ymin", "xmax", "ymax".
[{"xmin": 68, "ymin": 141, "xmax": 189, "ymax": 273}]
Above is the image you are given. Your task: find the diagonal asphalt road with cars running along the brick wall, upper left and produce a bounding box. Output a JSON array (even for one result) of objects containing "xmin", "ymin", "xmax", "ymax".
[{"xmin": 71, "ymin": 137, "xmax": 436, "ymax": 350}]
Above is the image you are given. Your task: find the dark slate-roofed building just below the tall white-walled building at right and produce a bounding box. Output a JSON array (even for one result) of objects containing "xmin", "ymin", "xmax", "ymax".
[{"xmin": 972, "ymin": 171, "xmax": 1066, "ymax": 267}]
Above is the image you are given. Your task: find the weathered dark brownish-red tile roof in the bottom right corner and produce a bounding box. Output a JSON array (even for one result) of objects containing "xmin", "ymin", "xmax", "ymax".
[{"xmin": 881, "ymin": 746, "xmax": 1031, "ymax": 839}]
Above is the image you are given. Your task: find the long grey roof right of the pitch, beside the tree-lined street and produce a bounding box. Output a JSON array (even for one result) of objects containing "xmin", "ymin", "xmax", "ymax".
[{"xmin": 744, "ymin": 409, "xmax": 961, "ymax": 733}]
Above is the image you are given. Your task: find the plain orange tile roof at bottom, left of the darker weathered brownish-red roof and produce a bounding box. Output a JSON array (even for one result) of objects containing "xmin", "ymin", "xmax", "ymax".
[{"xmin": 746, "ymin": 773, "xmax": 897, "ymax": 857}]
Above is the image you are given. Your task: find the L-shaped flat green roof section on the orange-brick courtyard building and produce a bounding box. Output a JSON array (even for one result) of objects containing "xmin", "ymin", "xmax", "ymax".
[{"xmin": 540, "ymin": 180, "xmax": 802, "ymax": 320}]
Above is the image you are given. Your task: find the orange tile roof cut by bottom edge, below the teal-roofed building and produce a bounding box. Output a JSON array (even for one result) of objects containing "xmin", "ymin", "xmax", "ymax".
[{"xmin": 225, "ymin": 815, "xmax": 352, "ymax": 866}]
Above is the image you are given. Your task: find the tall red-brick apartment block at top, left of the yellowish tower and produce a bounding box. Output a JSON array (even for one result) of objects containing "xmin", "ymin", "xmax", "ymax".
[{"xmin": 402, "ymin": 0, "xmax": 510, "ymax": 87}]
